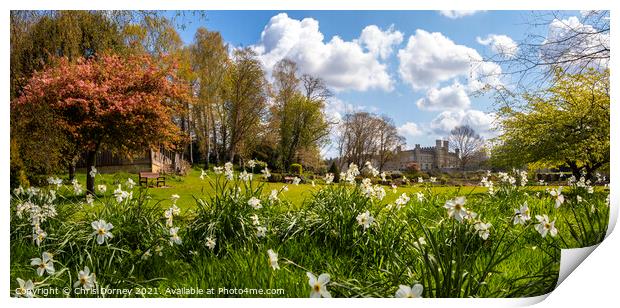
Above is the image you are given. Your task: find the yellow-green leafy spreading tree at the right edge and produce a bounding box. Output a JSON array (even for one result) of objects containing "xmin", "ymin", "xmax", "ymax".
[{"xmin": 492, "ymin": 69, "xmax": 610, "ymax": 177}]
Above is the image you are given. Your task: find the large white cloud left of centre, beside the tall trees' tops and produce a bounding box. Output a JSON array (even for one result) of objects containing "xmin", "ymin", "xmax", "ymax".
[{"xmin": 253, "ymin": 13, "xmax": 396, "ymax": 91}]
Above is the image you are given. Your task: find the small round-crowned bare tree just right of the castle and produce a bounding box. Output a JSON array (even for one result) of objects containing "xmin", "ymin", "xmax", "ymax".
[{"xmin": 448, "ymin": 125, "xmax": 484, "ymax": 170}]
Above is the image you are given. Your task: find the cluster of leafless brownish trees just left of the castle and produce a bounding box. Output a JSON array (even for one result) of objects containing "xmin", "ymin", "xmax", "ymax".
[{"xmin": 338, "ymin": 112, "xmax": 405, "ymax": 170}]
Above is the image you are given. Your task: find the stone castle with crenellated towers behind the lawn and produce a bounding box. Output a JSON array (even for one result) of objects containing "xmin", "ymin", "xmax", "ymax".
[{"xmin": 383, "ymin": 140, "xmax": 459, "ymax": 171}]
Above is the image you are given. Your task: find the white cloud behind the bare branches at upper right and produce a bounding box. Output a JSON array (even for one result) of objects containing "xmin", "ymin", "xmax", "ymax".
[{"xmin": 541, "ymin": 16, "xmax": 610, "ymax": 70}]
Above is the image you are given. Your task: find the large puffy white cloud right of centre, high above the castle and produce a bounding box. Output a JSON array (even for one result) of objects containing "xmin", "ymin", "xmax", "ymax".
[{"xmin": 398, "ymin": 29, "xmax": 482, "ymax": 89}]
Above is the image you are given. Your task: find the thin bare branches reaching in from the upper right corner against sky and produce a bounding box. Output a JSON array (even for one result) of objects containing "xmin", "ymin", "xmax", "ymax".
[{"xmin": 479, "ymin": 11, "xmax": 610, "ymax": 107}]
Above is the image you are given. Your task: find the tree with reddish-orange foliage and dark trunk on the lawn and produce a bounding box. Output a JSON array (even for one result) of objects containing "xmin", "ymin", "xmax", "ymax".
[{"xmin": 11, "ymin": 55, "xmax": 190, "ymax": 193}]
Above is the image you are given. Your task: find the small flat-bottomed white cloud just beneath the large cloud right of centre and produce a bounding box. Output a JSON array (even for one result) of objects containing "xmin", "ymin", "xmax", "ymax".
[{"xmin": 416, "ymin": 82, "xmax": 470, "ymax": 110}]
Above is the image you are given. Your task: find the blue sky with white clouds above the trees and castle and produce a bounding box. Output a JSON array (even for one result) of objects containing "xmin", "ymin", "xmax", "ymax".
[{"xmin": 165, "ymin": 11, "xmax": 583, "ymax": 157}]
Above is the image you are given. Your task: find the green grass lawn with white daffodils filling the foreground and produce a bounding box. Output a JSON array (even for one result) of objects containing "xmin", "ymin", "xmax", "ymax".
[{"xmin": 10, "ymin": 170, "xmax": 608, "ymax": 297}]
